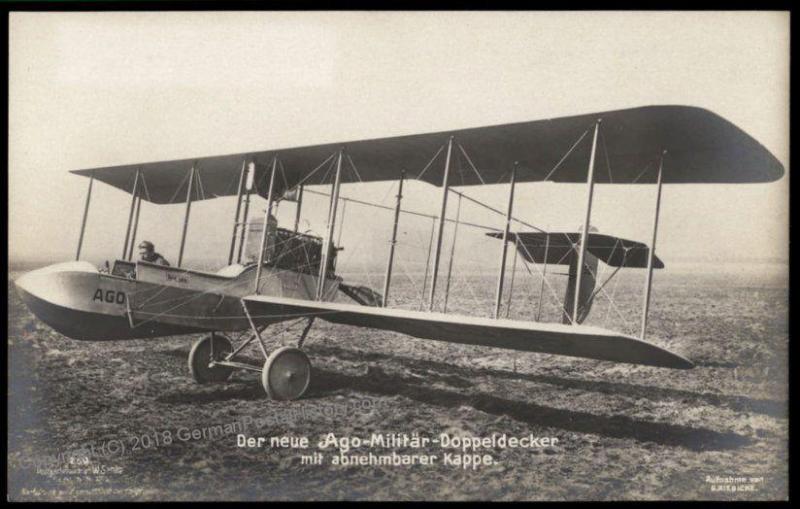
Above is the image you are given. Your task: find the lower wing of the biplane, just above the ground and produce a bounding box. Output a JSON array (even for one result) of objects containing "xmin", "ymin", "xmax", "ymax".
[{"xmin": 244, "ymin": 295, "xmax": 693, "ymax": 369}]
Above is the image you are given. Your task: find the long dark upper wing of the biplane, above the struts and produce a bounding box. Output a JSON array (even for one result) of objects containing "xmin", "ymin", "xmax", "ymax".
[{"xmin": 73, "ymin": 106, "xmax": 783, "ymax": 203}]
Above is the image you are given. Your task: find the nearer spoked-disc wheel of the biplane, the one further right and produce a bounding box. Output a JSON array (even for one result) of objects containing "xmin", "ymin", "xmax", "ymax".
[{"xmin": 261, "ymin": 346, "xmax": 311, "ymax": 401}]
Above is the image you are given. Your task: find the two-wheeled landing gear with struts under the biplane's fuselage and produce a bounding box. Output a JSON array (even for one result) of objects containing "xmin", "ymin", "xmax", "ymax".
[{"xmin": 189, "ymin": 303, "xmax": 314, "ymax": 401}]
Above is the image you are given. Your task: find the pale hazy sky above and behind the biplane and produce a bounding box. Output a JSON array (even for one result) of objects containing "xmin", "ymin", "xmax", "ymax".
[{"xmin": 8, "ymin": 12, "xmax": 789, "ymax": 274}]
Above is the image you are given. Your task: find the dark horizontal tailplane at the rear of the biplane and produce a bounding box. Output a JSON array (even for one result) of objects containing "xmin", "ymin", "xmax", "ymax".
[{"xmin": 486, "ymin": 232, "xmax": 664, "ymax": 269}]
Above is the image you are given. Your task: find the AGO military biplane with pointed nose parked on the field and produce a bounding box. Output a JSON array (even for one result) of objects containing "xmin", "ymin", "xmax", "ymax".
[{"xmin": 16, "ymin": 106, "xmax": 784, "ymax": 400}]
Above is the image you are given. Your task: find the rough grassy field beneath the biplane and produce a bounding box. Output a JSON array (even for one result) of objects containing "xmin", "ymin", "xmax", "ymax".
[{"xmin": 8, "ymin": 273, "xmax": 789, "ymax": 500}]
